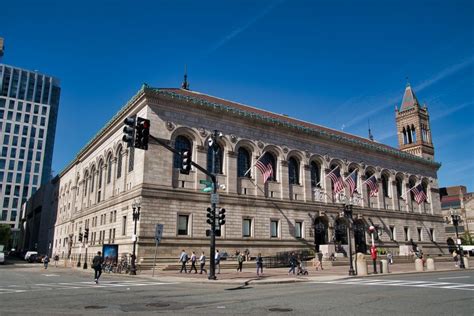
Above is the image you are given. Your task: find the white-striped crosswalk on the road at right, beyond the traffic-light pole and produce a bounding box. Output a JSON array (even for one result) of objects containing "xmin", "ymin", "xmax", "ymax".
[{"xmin": 312, "ymin": 278, "xmax": 474, "ymax": 291}]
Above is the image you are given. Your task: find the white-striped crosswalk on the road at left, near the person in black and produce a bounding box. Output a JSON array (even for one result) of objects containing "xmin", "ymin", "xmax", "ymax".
[{"xmin": 0, "ymin": 280, "xmax": 176, "ymax": 295}]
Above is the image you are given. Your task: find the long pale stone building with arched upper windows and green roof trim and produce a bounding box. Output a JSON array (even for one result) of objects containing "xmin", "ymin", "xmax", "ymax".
[{"xmin": 53, "ymin": 85, "xmax": 447, "ymax": 260}]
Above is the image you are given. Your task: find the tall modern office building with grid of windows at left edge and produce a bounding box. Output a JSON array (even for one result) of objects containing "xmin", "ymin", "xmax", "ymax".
[{"xmin": 0, "ymin": 64, "xmax": 61, "ymax": 228}]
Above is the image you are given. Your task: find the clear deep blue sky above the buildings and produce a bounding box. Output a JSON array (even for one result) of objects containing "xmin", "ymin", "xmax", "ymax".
[{"xmin": 0, "ymin": 0, "xmax": 474, "ymax": 191}]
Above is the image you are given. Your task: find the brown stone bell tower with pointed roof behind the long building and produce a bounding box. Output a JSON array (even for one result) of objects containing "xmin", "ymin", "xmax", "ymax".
[{"xmin": 395, "ymin": 84, "xmax": 434, "ymax": 161}]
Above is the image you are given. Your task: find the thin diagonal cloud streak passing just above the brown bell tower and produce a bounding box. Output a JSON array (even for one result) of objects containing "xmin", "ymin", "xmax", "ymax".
[{"xmin": 344, "ymin": 56, "xmax": 474, "ymax": 130}]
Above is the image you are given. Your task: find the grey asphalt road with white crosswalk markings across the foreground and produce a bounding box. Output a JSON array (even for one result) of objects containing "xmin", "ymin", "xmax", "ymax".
[{"xmin": 0, "ymin": 265, "xmax": 474, "ymax": 315}]
